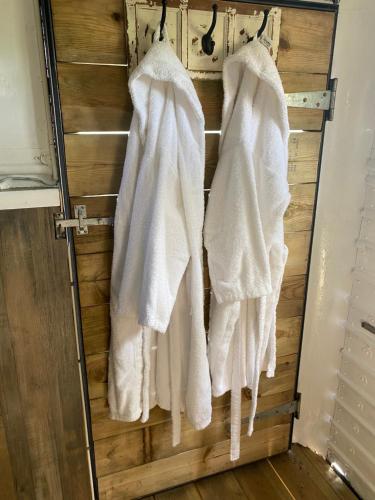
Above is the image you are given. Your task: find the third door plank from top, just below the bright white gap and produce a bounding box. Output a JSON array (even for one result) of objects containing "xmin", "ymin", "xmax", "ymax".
[{"xmin": 65, "ymin": 132, "xmax": 321, "ymax": 196}]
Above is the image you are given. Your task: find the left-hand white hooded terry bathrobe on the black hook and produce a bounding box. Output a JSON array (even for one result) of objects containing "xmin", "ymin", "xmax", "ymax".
[{"xmin": 108, "ymin": 33, "xmax": 211, "ymax": 445}]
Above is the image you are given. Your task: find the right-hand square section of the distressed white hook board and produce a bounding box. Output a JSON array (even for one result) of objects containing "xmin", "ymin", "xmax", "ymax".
[{"xmin": 233, "ymin": 8, "xmax": 281, "ymax": 61}]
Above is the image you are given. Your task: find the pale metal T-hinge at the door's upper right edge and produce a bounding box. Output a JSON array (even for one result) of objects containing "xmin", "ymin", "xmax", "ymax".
[{"xmin": 285, "ymin": 78, "xmax": 338, "ymax": 121}]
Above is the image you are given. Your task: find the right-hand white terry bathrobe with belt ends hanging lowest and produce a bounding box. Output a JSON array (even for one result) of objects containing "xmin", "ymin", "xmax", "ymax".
[{"xmin": 204, "ymin": 40, "xmax": 290, "ymax": 460}]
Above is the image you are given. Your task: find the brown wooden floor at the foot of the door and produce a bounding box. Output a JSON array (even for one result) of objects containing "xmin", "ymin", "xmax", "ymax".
[{"xmin": 147, "ymin": 445, "xmax": 356, "ymax": 500}]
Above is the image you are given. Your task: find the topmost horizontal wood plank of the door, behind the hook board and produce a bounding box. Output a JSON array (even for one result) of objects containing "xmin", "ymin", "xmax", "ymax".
[{"xmin": 52, "ymin": 0, "xmax": 334, "ymax": 73}]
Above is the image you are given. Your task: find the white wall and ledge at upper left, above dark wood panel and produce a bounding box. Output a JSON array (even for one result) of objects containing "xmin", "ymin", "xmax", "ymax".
[{"xmin": 0, "ymin": 0, "xmax": 59, "ymax": 209}]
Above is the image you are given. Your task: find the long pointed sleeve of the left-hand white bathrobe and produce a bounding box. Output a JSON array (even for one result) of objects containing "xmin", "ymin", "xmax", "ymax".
[{"xmin": 112, "ymin": 80, "xmax": 190, "ymax": 332}]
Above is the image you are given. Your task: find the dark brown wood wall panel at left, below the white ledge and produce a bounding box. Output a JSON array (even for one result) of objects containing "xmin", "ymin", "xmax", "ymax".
[{"xmin": 0, "ymin": 208, "xmax": 91, "ymax": 499}]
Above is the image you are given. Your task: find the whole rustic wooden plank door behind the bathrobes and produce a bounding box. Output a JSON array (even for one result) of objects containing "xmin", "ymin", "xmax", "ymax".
[{"xmin": 47, "ymin": 0, "xmax": 335, "ymax": 499}]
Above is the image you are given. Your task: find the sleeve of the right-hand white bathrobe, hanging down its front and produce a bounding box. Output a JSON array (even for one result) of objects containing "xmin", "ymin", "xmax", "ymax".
[{"xmin": 205, "ymin": 67, "xmax": 289, "ymax": 303}]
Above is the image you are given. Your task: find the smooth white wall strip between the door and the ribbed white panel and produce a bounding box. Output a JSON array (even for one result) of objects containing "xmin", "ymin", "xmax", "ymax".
[{"xmin": 293, "ymin": 0, "xmax": 375, "ymax": 456}]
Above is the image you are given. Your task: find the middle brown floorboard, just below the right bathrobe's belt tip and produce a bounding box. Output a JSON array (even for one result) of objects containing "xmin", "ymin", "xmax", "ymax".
[{"xmin": 233, "ymin": 460, "xmax": 293, "ymax": 500}]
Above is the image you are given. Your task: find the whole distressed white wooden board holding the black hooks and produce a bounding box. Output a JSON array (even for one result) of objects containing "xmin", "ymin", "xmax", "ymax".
[{"xmin": 125, "ymin": 0, "xmax": 281, "ymax": 79}]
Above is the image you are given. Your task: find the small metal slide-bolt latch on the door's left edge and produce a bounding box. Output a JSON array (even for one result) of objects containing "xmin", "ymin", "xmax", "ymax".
[{"xmin": 54, "ymin": 205, "xmax": 114, "ymax": 240}]
